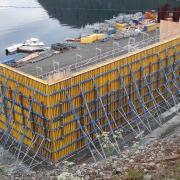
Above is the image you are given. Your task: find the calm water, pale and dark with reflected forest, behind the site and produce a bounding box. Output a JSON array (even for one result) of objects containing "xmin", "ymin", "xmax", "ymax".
[{"xmin": 0, "ymin": 0, "xmax": 180, "ymax": 61}]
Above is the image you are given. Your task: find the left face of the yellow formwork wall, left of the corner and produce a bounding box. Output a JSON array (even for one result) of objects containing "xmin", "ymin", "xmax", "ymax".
[{"xmin": 0, "ymin": 65, "xmax": 51, "ymax": 160}]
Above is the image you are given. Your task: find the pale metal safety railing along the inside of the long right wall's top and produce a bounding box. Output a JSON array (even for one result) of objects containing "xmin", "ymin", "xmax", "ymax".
[{"xmin": 38, "ymin": 32, "xmax": 171, "ymax": 79}]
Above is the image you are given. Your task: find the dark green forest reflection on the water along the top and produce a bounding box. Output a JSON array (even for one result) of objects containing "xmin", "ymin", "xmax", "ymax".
[{"xmin": 38, "ymin": 0, "xmax": 179, "ymax": 27}]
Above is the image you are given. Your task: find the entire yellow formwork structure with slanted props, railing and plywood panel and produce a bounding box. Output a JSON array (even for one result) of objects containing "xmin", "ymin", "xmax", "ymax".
[{"xmin": 0, "ymin": 15, "xmax": 180, "ymax": 176}]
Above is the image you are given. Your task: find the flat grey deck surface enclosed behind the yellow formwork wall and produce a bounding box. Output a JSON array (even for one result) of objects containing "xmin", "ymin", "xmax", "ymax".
[{"xmin": 17, "ymin": 30, "xmax": 159, "ymax": 79}]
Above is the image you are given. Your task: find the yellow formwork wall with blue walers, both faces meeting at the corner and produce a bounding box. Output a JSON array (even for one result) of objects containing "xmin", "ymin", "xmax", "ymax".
[{"xmin": 0, "ymin": 37, "xmax": 180, "ymax": 162}]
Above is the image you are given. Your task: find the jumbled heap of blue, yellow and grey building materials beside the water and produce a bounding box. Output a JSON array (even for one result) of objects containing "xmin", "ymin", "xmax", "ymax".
[{"xmin": 80, "ymin": 11, "xmax": 159, "ymax": 44}]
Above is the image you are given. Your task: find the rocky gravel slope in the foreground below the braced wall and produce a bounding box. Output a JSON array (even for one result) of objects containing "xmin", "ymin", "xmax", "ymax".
[{"xmin": 0, "ymin": 116, "xmax": 180, "ymax": 180}]
